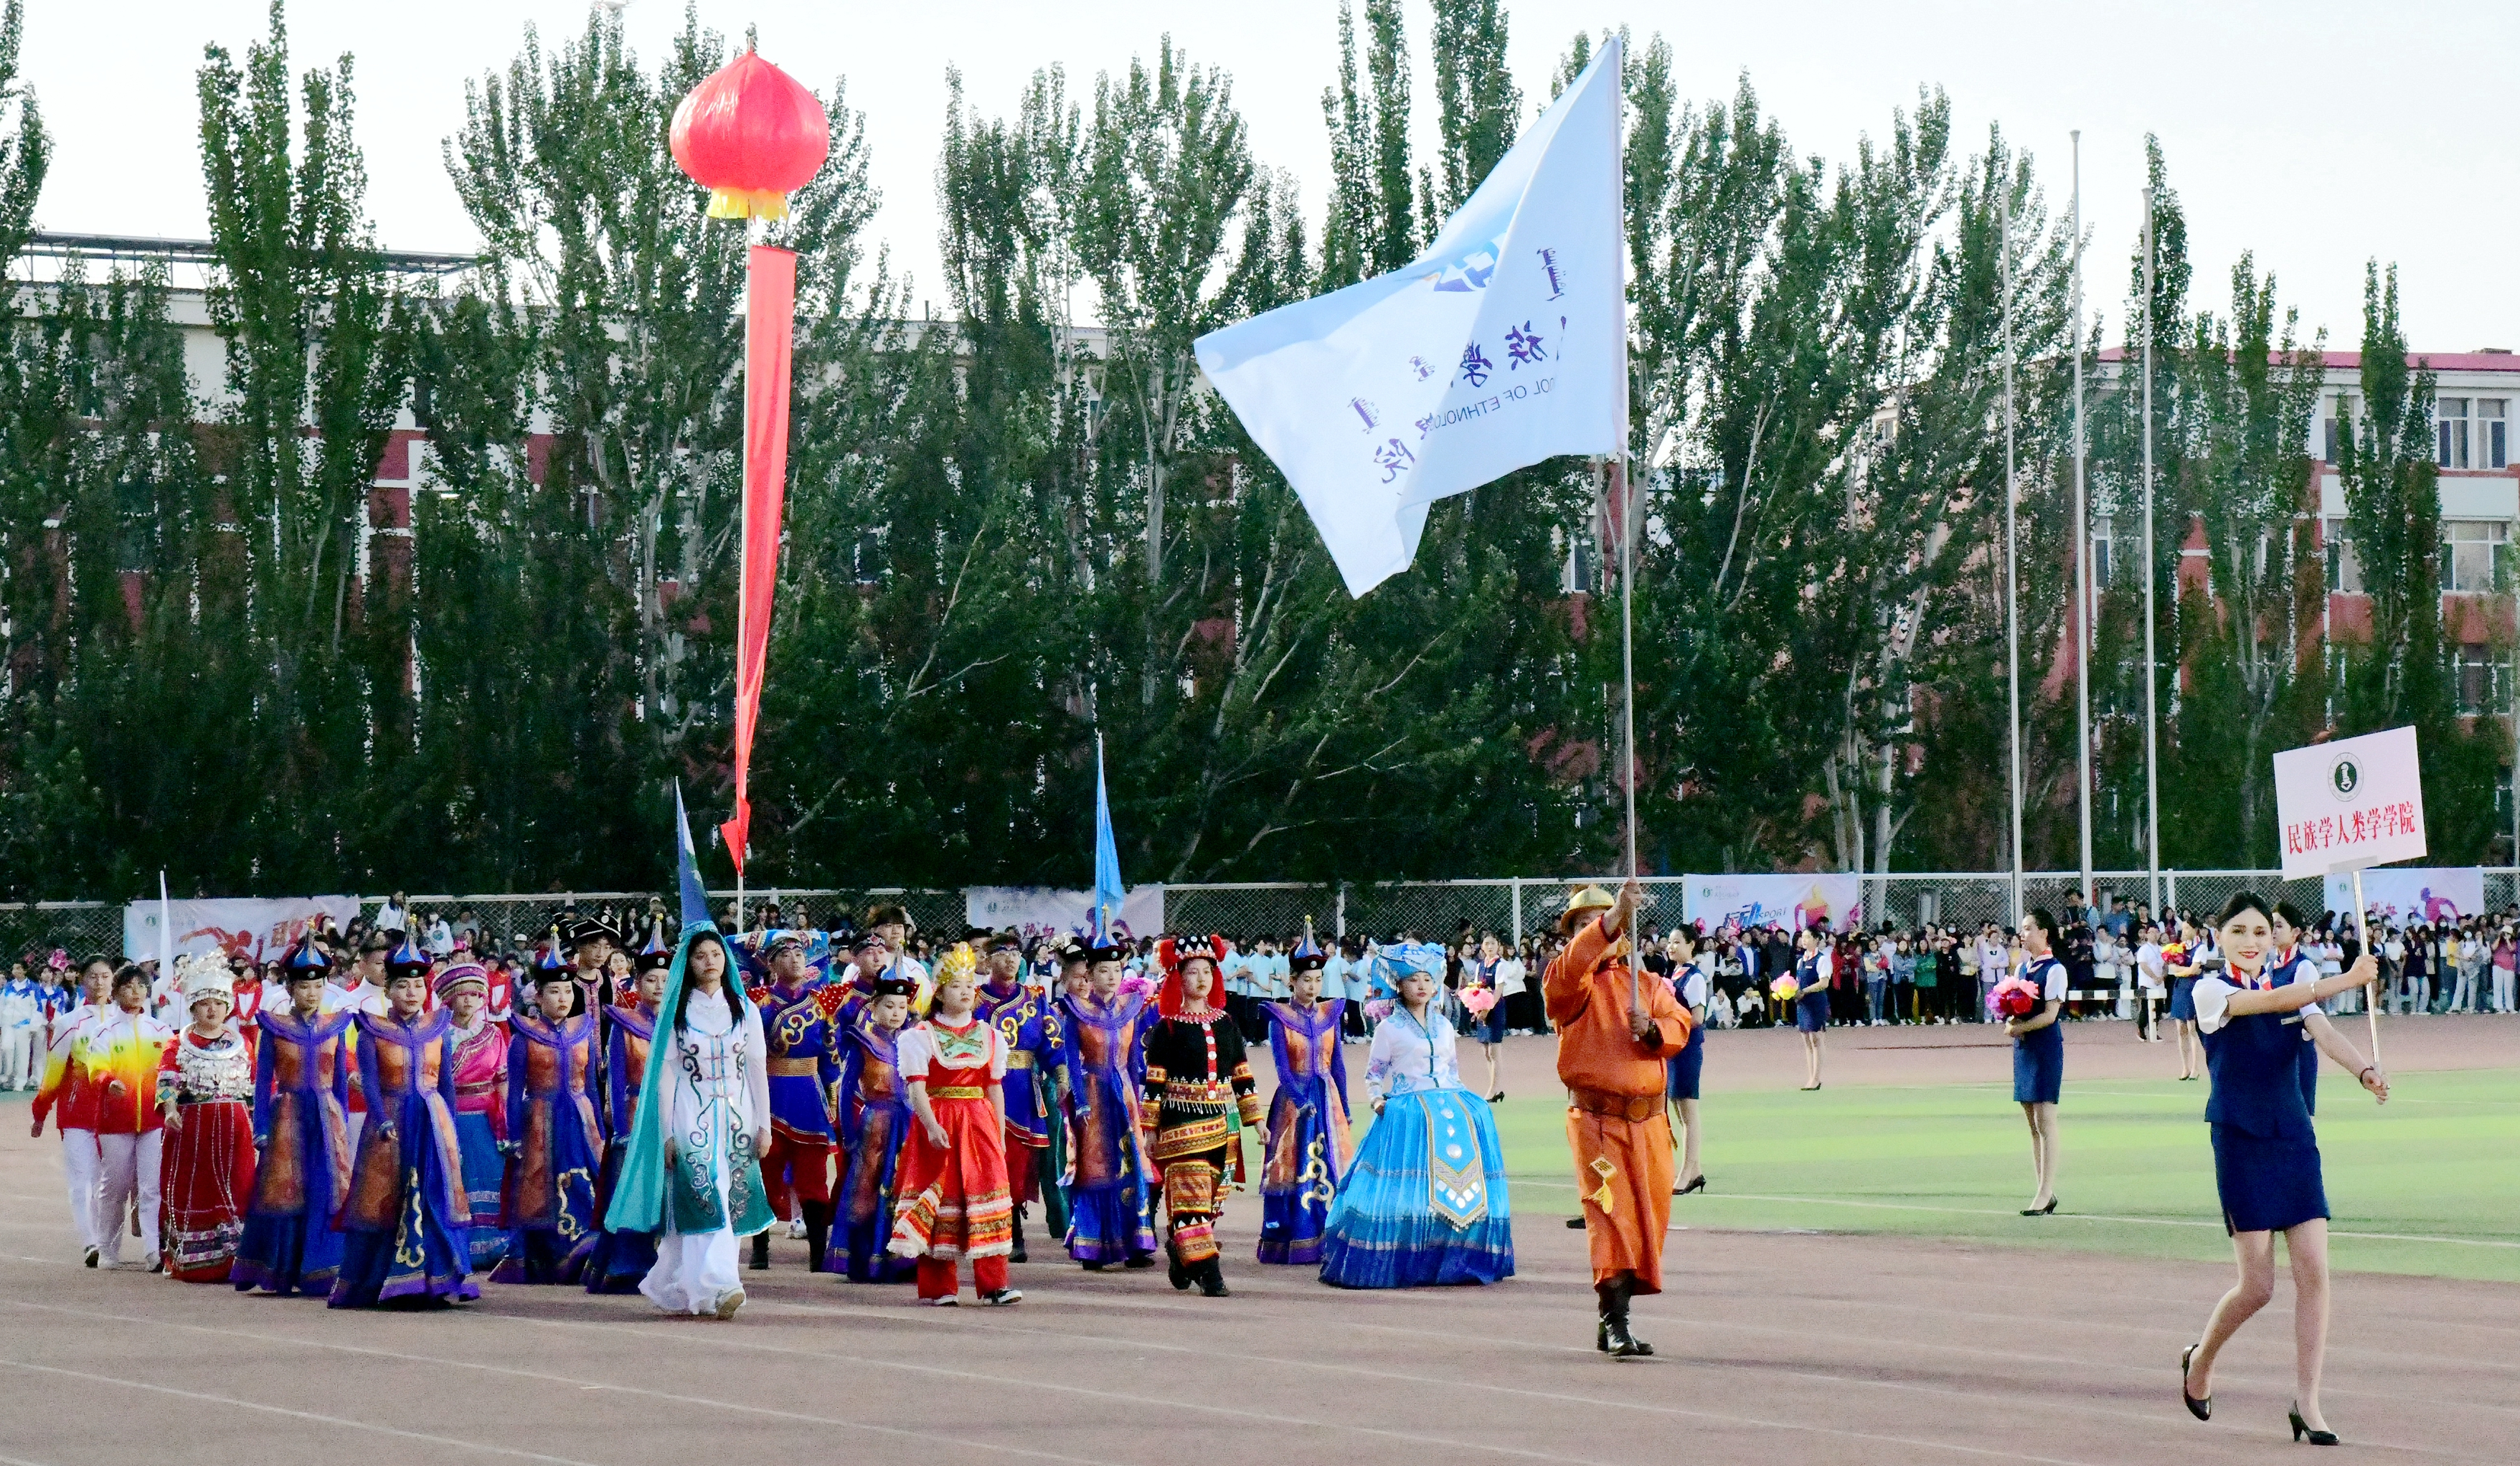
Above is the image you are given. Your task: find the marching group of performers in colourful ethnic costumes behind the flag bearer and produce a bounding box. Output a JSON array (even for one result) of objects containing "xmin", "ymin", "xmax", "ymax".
[{"xmin": 35, "ymin": 907, "xmax": 1514, "ymax": 1318}]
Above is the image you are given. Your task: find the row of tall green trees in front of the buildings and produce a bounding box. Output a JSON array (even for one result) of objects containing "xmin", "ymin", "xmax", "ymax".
[{"xmin": 0, "ymin": 0, "xmax": 2505, "ymax": 897}]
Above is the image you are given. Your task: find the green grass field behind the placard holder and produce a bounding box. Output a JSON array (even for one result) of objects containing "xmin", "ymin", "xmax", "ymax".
[{"xmin": 1497, "ymin": 1068, "xmax": 2520, "ymax": 1282}]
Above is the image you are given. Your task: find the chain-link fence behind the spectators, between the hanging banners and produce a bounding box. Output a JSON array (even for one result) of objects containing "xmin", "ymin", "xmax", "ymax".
[{"xmin": 19, "ymin": 866, "xmax": 2520, "ymax": 963}]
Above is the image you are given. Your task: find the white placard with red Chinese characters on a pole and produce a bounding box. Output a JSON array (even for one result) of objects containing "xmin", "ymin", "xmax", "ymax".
[{"xmin": 2275, "ymin": 728, "xmax": 2427, "ymax": 881}]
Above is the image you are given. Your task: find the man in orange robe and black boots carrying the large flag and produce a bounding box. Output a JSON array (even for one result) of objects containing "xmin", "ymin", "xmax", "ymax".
[{"xmin": 1539, "ymin": 879, "xmax": 1689, "ymax": 1358}]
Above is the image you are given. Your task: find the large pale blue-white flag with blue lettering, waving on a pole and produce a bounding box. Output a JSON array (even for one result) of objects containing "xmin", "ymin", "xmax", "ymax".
[{"xmin": 1197, "ymin": 40, "xmax": 1628, "ymax": 595}]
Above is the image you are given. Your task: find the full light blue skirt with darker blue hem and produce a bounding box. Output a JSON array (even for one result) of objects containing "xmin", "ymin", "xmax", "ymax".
[{"xmin": 1321, "ymin": 1088, "xmax": 1514, "ymax": 1287}]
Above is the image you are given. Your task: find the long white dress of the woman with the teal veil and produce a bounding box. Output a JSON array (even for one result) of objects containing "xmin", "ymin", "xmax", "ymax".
[{"xmin": 638, "ymin": 993, "xmax": 771, "ymax": 1313}]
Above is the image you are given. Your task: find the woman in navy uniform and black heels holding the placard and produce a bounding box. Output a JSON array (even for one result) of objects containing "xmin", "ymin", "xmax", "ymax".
[{"xmin": 2180, "ymin": 892, "xmax": 2389, "ymax": 1446}]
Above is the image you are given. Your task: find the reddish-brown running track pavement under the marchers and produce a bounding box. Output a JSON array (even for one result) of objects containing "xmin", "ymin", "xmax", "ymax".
[{"xmin": 0, "ymin": 1020, "xmax": 2520, "ymax": 1466}]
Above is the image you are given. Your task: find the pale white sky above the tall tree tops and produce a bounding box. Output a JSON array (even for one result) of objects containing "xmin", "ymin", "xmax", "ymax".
[{"xmin": 23, "ymin": 0, "xmax": 2520, "ymax": 353}]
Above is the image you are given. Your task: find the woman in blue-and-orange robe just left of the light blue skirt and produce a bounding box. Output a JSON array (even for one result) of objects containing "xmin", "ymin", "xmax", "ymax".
[{"xmin": 1260, "ymin": 932, "xmax": 1350, "ymax": 1267}]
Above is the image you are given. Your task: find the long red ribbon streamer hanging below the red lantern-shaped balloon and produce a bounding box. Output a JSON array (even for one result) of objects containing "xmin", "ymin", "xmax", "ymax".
[{"xmin": 718, "ymin": 245, "xmax": 796, "ymax": 874}]
